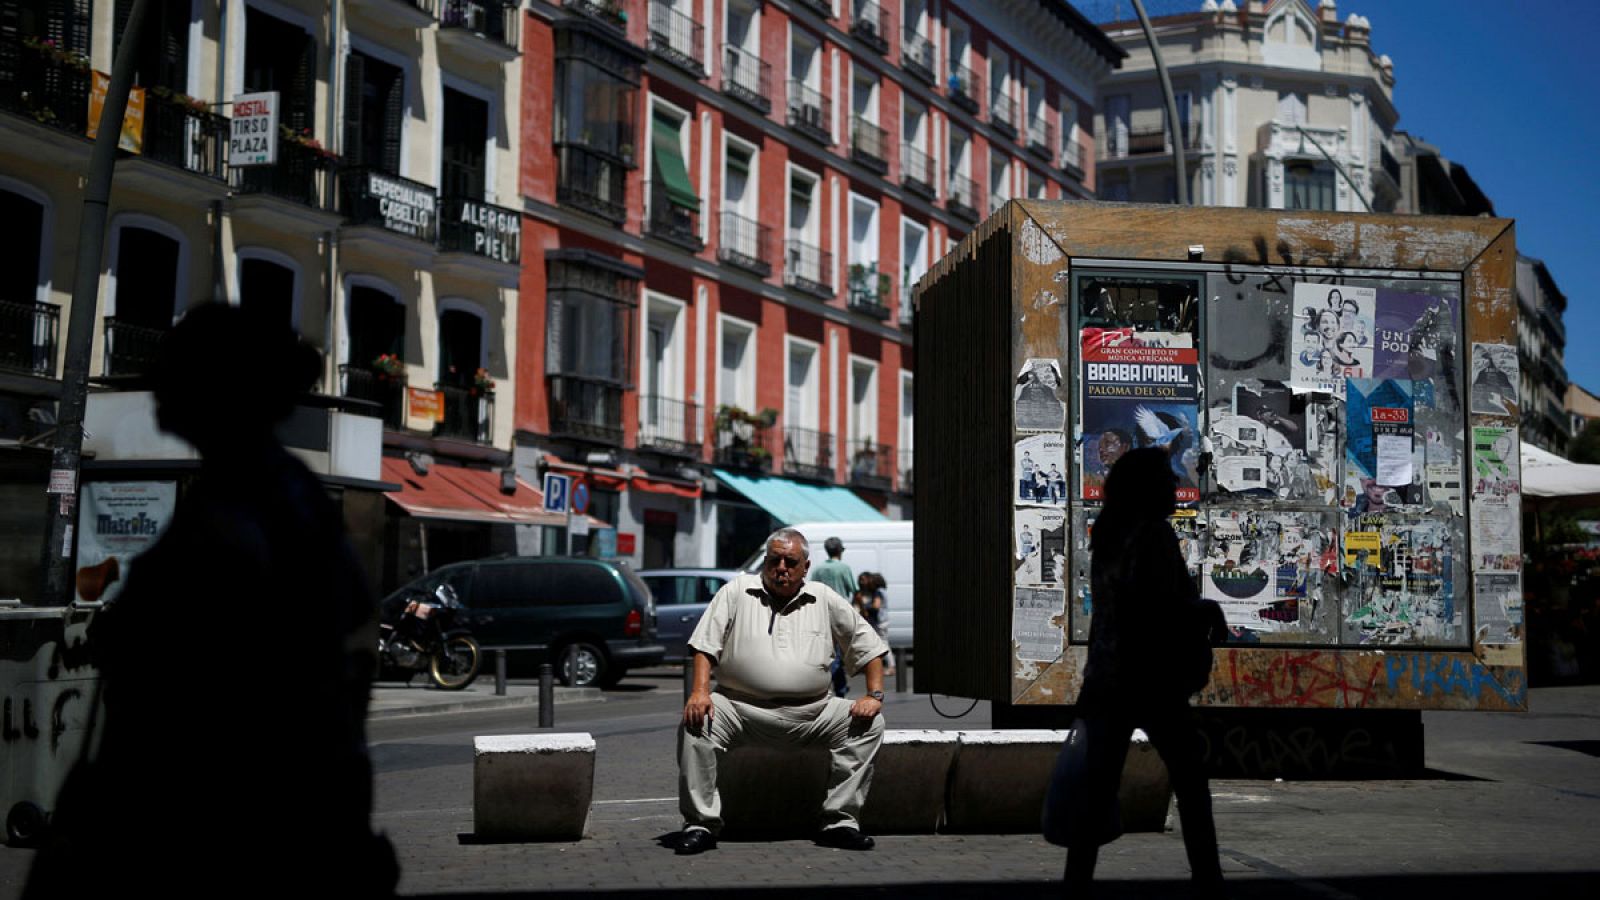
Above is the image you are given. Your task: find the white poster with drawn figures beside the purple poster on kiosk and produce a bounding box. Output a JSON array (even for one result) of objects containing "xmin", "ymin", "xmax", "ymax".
[{"xmin": 1290, "ymin": 282, "xmax": 1378, "ymax": 397}]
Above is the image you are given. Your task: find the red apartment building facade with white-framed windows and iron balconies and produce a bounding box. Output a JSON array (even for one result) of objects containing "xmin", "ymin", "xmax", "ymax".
[{"xmin": 514, "ymin": 0, "xmax": 1120, "ymax": 567}]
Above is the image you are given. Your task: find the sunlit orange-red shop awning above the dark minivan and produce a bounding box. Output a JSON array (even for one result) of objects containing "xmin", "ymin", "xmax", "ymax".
[{"xmin": 382, "ymin": 456, "xmax": 566, "ymax": 527}]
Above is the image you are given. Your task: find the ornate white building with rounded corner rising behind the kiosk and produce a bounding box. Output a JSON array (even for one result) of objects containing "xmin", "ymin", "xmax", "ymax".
[{"xmin": 1094, "ymin": 0, "xmax": 1400, "ymax": 211}]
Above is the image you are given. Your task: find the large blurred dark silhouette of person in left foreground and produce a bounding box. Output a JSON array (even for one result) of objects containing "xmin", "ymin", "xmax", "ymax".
[{"xmin": 26, "ymin": 304, "xmax": 398, "ymax": 897}]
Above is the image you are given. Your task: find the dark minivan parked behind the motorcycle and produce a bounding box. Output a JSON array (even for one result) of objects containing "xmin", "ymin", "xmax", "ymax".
[{"xmin": 384, "ymin": 556, "xmax": 666, "ymax": 687}]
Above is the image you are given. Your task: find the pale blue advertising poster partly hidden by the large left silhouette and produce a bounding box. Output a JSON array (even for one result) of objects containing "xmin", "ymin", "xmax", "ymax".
[{"xmin": 75, "ymin": 482, "xmax": 178, "ymax": 604}]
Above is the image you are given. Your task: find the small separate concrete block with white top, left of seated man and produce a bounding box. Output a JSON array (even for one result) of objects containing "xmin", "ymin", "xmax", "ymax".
[{"xmin": 472, "ymin": 732, "xmax": 595, "ymax": 841}]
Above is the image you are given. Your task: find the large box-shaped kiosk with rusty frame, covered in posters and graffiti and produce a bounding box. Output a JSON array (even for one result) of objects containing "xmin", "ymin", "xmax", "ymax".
[{"xmin": 915, "ymin": 200, "xmax": 1528, "ymax": 717}]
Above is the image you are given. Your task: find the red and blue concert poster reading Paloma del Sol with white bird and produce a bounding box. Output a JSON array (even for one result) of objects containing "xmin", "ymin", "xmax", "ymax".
[{"xmin": 1080, "ymin": 333, "xmax": 1200, "ymax": 503}]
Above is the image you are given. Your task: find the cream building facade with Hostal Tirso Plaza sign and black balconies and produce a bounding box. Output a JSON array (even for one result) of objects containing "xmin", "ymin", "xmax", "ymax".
[{"xmin": 0, "ymin": 0, "xmax": 533, "ymax": 595}]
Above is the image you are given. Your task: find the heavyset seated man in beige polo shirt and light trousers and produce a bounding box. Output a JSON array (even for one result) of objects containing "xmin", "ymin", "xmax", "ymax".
[{"xmin": 677, "ymin": 528, "xmax": 890, "ymax": 855}]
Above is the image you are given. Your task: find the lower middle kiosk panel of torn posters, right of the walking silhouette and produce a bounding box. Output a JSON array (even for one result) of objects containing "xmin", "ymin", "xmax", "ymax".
[{"xmin": 1200, "ymin": 509, "xmax": 1339, "ymax": 644}]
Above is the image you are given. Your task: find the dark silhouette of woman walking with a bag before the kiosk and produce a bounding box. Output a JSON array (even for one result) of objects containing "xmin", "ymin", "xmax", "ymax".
[{"xmin": 1066, "ymin": 447, "xmax": 1222, "ymax": 895}]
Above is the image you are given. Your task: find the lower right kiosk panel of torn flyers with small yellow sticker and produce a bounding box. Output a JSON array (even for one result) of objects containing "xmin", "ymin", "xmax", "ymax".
[{"xmin": 1344, "ymin": 512, "xmax": 1466, "ymax": 644}]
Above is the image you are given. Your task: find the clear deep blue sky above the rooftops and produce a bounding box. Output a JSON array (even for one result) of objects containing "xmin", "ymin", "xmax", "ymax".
[{"xmin": 1075, "ymin": 0, "xmax": 1600, "ymax": 385}]
